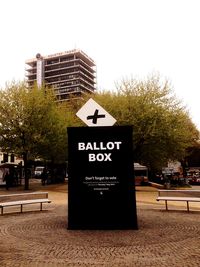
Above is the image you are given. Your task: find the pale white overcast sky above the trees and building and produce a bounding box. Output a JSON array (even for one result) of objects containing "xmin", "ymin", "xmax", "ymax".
[{"xmin": 0, "ymin": 0, "xmax": 200, "ymax": 129}]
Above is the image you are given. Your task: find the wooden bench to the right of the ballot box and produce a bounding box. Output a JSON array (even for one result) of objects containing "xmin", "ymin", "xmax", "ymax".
[{"xmin": 156, "ymin": 190, "xmax": 200, "ymax": 212}]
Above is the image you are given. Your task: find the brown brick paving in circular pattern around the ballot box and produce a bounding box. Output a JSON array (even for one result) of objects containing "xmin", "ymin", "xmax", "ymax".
[{"xmin": 0, "ymin": 183, "xmax": 200, "ymax": 267}]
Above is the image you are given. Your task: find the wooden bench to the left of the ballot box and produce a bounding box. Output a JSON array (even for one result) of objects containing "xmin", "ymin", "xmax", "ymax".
[{"xmin": 0, "ymin": 192, "xmax": 51, "ymax": 215}]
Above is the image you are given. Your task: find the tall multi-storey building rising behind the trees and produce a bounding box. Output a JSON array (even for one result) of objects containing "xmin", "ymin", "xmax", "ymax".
[{"xmin": 26, "ymin": 49, "xmax": 96, "ymax": 101}]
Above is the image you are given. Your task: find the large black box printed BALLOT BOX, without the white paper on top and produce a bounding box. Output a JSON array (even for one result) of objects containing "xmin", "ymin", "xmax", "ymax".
[{"xmin": 67, "ymin": 126, "xmax": 138, "ymax": 229}]
